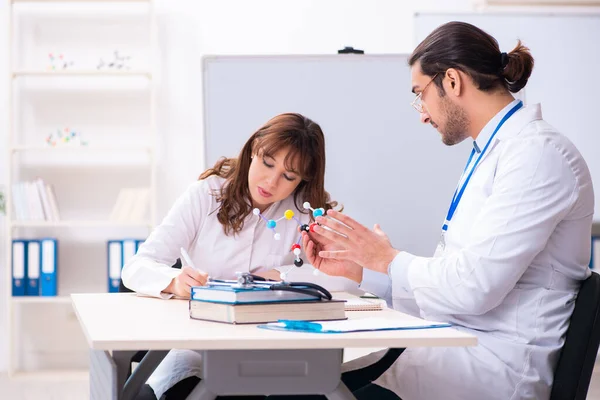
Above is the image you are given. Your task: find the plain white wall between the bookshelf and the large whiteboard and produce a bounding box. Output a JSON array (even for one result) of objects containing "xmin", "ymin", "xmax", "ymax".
[{"xmin": 0, "ymin": 0, "xmax": 478, "ymax": 370}]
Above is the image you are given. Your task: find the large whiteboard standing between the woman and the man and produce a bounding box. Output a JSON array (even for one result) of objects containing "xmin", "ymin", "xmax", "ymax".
[{"xmin": 203, "ymin": 55, "xmax": 471, "ymax": 255}]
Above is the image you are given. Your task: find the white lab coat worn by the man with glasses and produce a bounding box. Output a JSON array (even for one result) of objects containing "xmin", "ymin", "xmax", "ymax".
[{"xmin": 356, "ymin": 102, "xmax": 594, "ymax": 400}]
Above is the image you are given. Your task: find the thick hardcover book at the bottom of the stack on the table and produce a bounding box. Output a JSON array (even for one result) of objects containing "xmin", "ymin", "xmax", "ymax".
[{"xmin": 189, "ymin": 299, "xmax": 346, "ymax": 324}]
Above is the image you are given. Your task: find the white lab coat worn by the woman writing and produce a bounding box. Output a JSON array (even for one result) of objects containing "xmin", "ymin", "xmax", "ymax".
[{"xmin": 122, "ymin": 176, "xmax": 358, "ymax": 398}]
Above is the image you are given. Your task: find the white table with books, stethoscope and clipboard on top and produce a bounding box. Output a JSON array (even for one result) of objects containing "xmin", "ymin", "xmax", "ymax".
[{"xmin": 71, "ymin": 293, "xmax": 477, "ymax": 400}]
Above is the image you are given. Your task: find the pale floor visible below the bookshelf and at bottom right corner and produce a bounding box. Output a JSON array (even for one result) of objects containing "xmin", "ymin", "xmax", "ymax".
[{"xmin": 0, "ymin": 362, "xmax": 600, "ymax": 400}]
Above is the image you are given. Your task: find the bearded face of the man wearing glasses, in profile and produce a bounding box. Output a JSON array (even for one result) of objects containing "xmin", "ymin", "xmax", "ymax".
[{"xmin": 411, "ymin": 62, "xmax": 469, "ymax": 146}]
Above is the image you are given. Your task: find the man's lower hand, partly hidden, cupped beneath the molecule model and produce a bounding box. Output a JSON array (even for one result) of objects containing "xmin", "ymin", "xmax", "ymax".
[{"xmin": 302, "ymin": 227, "xmax": 362, "ymax": 283}]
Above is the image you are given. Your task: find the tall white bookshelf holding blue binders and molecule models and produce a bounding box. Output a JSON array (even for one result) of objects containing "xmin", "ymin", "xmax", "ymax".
[{"xmin": 4, "ymin": 0, "xmax": 157, "ymax": 381}]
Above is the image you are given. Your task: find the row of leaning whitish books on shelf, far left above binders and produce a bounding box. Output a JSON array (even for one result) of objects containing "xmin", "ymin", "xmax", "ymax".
[{"xmin": 11, "ymin": 178, "xmax": 60, "ymax": 221}]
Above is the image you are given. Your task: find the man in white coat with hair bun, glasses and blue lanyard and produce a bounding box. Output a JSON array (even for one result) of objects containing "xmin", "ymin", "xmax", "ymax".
[{"xmin": 304, "ymin": 22, "xmax": 594, "ymax": 400}]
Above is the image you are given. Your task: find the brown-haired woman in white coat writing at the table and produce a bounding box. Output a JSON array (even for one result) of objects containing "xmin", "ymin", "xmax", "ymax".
[{"xmin": 122, "ymin": 114, "xmax": 336, "ymax": 399}]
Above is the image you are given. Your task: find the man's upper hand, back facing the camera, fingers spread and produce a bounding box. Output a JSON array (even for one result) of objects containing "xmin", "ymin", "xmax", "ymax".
[{"xmin": 314, "ymin": 210, "xmax": 399, "ymax": 273}]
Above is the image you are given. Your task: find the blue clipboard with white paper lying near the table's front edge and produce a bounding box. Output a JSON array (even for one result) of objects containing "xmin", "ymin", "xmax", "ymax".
[{"xmin": 258, "ymin": 318, "xmax": 451, "ymax": 333}]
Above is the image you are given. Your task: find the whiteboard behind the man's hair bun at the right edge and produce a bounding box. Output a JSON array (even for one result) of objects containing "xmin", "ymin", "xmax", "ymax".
[{"xmin": 415, "ymin": 13, "xmax": 600, "ymax": 221}]
